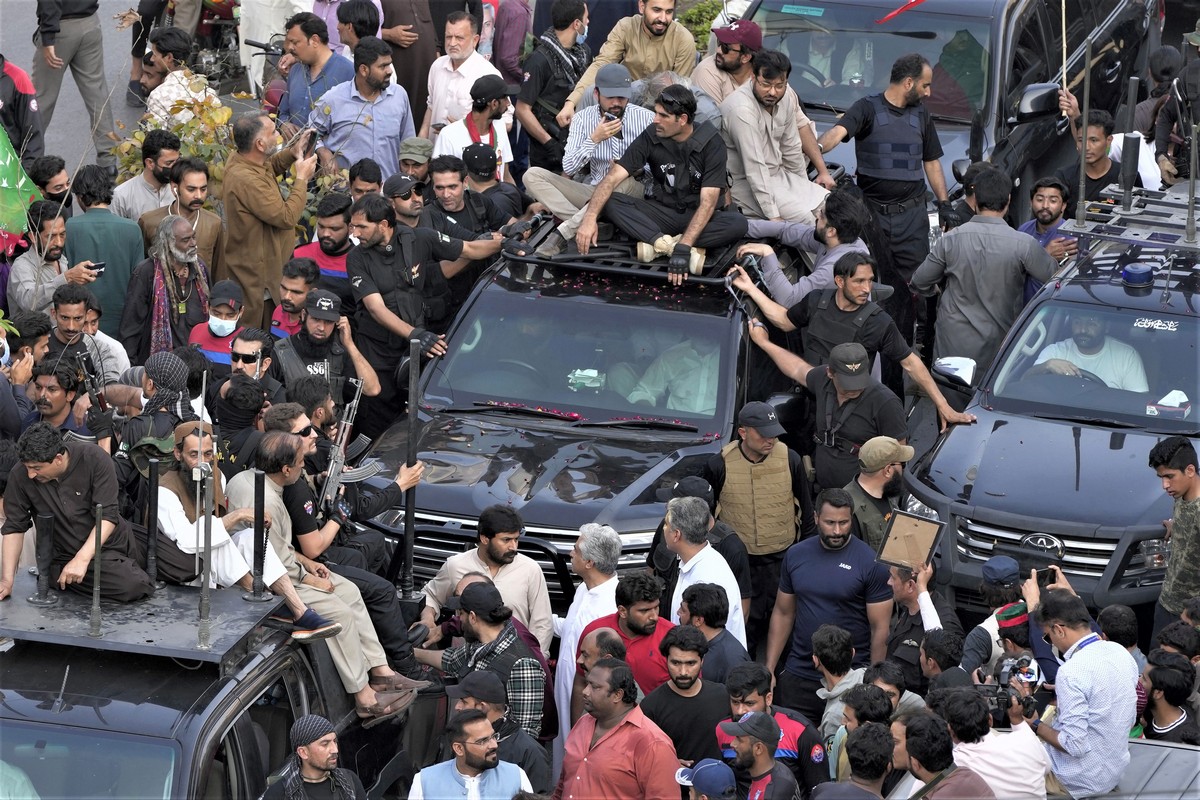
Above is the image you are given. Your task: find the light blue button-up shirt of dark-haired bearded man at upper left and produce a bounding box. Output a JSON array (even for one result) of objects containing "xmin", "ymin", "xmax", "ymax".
[{"xmin": 308, "ymin": 80, "xmax": 416, "ymax": 180}]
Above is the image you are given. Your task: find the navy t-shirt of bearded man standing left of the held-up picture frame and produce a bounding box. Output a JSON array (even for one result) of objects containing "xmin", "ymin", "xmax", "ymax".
[{"xmin": 779, "ymin": 536, "xmax": 892, "ymax": 680}]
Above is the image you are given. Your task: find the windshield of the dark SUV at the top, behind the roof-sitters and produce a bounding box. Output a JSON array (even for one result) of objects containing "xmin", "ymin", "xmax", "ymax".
[{"xmin": 754, "ymin": 0, "xmax": 991, "ymax": 122}]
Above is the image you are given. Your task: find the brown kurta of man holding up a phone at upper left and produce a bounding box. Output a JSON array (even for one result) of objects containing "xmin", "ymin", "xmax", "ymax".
[{"xmin": 219, "ymin": 150, "xmax": 308, "ymax": 330}]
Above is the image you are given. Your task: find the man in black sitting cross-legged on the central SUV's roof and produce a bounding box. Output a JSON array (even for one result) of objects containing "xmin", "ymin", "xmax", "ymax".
[{"xmin": 575, "ymin": 84, "xmax": 746, "ymax": 285}]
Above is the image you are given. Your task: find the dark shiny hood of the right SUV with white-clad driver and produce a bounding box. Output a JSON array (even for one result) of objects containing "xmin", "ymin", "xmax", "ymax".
[{"xmin": 913, "ymin": 405, "xmax": 1171, "ymax": 528}]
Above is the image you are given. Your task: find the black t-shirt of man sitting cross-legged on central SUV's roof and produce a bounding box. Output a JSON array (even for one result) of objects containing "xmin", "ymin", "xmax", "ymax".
[{"xmin": 617, "ymin": 122, "xmax": 728, "ymax": 210}]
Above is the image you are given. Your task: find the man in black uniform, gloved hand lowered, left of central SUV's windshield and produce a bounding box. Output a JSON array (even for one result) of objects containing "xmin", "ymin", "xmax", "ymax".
[{"xmin": 346, "ymin": 194, "xmax": 462, "ymax": 439}]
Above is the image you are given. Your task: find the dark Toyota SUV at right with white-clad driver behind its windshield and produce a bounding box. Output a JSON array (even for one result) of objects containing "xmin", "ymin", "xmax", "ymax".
[{"xmin": 906, "ymin": 190, "xmax": 1200, "ymax": 610}]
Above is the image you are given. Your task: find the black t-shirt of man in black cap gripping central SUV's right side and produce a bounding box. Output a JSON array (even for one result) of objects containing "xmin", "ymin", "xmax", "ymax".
[{"xmin": 806, "ymin": 368, "xmax": 908, "ymax": 489}]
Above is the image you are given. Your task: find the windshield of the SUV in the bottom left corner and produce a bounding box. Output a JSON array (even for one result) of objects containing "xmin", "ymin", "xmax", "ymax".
[{"xmin": 0, "ymin": 724, "xmax": 179, "ymax": 800}]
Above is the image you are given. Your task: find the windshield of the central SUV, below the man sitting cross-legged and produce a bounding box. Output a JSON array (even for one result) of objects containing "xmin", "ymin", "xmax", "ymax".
[{"xmin": 425, "ymin": 272, "xmax": 732, "ymax": 431}]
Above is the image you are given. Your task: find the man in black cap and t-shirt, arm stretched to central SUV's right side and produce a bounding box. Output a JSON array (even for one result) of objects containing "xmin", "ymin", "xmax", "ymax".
[{"xmin": 750, "ymin": 335, "xmax": 908, "ymax": 489}]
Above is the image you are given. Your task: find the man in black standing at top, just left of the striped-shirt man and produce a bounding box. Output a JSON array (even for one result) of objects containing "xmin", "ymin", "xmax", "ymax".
[{"xmin": 516, "ymin": 0, "xmax": 592, "ymax": 173}]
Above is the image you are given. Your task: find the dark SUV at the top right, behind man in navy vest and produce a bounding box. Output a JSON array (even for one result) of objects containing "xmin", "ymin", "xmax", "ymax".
[{"xmin": 745, "ymin": 0, "xmax": 1163, "ymax": 221}]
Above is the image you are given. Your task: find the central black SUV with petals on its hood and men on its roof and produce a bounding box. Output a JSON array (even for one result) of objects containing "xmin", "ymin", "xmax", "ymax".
[{"xmin": 368, "ymin": 257, "xmax": 748, "ymax": 608}]
